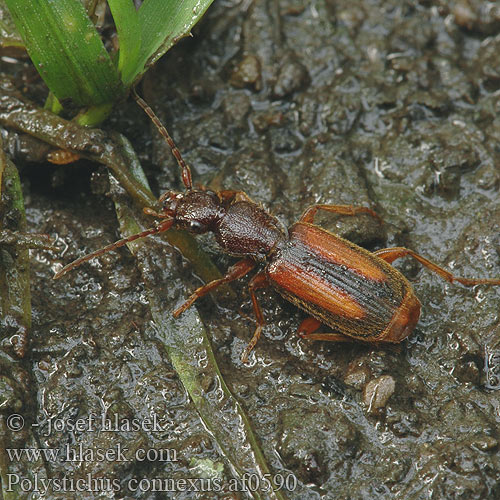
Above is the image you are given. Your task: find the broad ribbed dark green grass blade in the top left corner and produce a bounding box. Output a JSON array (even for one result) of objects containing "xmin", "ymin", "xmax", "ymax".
[{"xmin": 5, "ymin": 0, "xmax": 123, "ymax": 106}]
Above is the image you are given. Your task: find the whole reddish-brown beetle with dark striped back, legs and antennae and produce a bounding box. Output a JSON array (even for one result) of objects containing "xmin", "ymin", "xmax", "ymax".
[{"xmin": 54, "ymin": 91, "xmax": 500, "ymax": 362}]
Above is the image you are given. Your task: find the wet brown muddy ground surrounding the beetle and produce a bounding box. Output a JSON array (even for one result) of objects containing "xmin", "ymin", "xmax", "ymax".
[{"xmin": 0, "ymin": 0, "xmax": 500, "ymax": 500}]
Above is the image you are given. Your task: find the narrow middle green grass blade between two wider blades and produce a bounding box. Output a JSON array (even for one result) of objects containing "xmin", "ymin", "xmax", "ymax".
[{"xmin": 108, "ymin": 0, "xmax": 141, "ymax": 87}]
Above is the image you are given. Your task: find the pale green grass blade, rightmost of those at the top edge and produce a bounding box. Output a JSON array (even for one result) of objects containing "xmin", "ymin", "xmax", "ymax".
[{"xmin": 135, "ymin": 0, "xmax": 213, "ymax": 82}]
